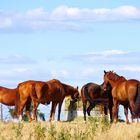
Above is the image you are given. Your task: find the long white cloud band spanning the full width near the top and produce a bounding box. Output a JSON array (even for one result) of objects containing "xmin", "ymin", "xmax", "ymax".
[{"xmin": 0, "ymin": 5, "xmax": 140, "ymax": 31}]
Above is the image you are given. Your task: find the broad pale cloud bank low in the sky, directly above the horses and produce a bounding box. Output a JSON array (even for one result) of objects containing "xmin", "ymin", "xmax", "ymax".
[{"xmin": 0, "ymin": 50, "xmax": 140, "ymax": 87}]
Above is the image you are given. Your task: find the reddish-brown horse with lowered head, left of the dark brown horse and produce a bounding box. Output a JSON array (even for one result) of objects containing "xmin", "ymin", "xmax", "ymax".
[{"xmin": 32, "ymin": 79, "xmax": 79, "ymax": 121}]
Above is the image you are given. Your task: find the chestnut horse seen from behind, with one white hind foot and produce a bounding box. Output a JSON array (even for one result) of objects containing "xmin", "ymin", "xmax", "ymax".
[{"xmin": 16, "ymin": 80, "xmax": 46, "ymax": 122}]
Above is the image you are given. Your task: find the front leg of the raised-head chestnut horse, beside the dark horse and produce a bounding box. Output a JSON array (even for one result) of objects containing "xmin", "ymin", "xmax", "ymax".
[{"xmin": 113, "ymin": 99, "xmax": 118, "ymax": 123}]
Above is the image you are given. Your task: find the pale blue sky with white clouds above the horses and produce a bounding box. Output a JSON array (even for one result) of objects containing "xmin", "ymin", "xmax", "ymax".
[{"xmin": 0, "ymin": 0, "xmax": 140, "ymax": 120}]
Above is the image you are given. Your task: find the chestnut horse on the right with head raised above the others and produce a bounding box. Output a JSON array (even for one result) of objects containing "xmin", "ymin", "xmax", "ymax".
[{"xmin": 103, "ymin": 71, "xmax": 140, "ymax": 123}]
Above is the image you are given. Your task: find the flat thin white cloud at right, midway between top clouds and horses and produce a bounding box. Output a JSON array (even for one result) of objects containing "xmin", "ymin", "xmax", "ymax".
[{"xmin": 76, "ymin": 50, "xmax": 140, "ymax": 65}]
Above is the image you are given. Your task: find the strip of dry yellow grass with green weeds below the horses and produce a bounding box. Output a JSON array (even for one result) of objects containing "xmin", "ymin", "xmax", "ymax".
[{"xmin": 0, "ymin": 118, "xmax": 140, "ymax": 140}]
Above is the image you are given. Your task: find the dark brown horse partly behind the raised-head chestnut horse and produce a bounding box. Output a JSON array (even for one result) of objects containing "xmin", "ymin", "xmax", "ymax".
[{"xmin": 81, "ymin": 83, "xmax": 112, "ymax": 122}]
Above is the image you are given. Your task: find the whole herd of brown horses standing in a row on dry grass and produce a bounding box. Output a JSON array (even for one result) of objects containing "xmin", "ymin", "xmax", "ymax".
[{"xmin": 0, "ymin": 71, "xmax": 140, "ymax": 123}]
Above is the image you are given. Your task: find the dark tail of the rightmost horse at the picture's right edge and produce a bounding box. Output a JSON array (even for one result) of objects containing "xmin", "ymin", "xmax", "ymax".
[{"xmin": 135, "ymin": 82, "xmax": 140, "ymax": 118}]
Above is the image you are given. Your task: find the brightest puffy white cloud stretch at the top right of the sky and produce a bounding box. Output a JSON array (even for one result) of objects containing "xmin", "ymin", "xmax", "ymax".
[{"xmin": 51, "ymin": 5, "xmax": 140, "ymax": 22}]
